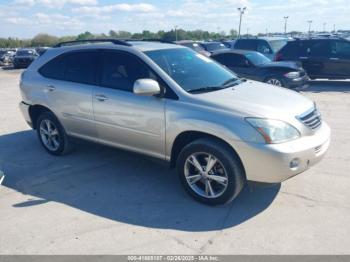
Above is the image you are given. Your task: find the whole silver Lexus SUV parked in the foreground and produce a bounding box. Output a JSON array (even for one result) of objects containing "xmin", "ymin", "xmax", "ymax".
[{"xmin": 20, "ymin": 40, "xmax": 330, "ymax": 205}]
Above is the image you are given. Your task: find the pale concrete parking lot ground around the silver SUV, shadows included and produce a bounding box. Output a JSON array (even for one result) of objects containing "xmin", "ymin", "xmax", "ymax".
[{"xmin": 0, "ymin": 69, "xmax": 350, "ymax": 254}]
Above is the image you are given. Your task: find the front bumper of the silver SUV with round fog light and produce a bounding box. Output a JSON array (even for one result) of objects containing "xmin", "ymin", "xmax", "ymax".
[{"xmin": 236, "ymin": 122, "xmax": 331, "ymax": 183}]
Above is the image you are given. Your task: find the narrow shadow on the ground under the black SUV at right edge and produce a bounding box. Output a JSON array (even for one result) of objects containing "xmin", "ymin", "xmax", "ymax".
[{"xmin": 302, "ymin": 80, "xmax": 350, "ymax": 93}]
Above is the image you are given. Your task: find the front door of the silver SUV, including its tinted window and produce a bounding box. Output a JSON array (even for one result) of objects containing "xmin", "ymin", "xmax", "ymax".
[{"xmin": 93, "ymin": 51, "xmax": 165, "ymax": 157}]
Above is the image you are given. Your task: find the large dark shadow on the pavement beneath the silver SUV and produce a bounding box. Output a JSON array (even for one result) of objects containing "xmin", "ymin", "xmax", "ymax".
[{"xmin": 0, "ymin": 131, "xmax": 280, "ymax": 232}]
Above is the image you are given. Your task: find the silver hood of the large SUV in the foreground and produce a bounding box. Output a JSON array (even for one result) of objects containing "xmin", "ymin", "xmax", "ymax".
[{"xmin": 193, "ymin": 80, "xmax": 314, "ymax": 119}]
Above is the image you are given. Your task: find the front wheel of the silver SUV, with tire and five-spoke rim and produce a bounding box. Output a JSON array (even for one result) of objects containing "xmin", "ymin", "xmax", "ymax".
[{"xmin": 177, "ymin": 138, "xmax": 246, "ymax": 205}]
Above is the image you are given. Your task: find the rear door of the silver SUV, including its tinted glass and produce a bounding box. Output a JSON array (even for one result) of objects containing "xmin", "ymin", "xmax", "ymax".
[{"xmin": 39, "ymin": 50, "xmax": 97, "ymax": 138}]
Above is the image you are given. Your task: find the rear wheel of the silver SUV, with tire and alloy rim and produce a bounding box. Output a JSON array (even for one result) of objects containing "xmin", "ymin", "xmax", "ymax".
[{"xmin": 36, "ymin": 112, "xmax": 70, "ymax": 156}]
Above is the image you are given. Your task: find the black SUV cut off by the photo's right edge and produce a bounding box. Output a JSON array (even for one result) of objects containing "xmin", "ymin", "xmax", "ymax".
[{"xmin": 275, "ymin": 38, "xmax": 350, "ymax": 79}]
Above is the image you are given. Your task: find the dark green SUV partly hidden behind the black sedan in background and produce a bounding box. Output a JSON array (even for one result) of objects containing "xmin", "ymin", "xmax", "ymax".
[{"xmin": 234, "ymin": 37, "xmax": 288, "ymax": 60}]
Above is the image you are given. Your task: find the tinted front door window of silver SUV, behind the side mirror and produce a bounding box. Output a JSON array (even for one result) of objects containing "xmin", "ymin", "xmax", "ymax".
[{"xmin": 101, "ymin": 52, "xmax": 157, "ymax": 92}]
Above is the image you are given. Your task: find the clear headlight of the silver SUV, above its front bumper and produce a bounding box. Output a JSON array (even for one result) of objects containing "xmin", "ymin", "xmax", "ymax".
[{"xmin": 246, "ymin": 117, "xmax": 300, "ymax": 144}]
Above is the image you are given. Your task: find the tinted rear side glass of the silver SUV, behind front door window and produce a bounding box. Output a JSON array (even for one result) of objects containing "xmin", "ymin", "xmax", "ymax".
[{"xmin": 39, "ymin": 51, "xmax": 97, "ymax": 85}]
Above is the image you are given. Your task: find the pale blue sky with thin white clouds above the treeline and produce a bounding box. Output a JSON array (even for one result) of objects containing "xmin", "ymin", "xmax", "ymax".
[{"xmin": 0, "ymin": 0, "xmax": 350, "ymax": 38}]
